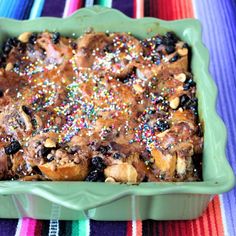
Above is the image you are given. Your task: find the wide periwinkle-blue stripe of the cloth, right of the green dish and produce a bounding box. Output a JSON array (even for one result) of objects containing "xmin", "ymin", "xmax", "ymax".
[{"xmin": 195, "ymin": 0, "xmax": 236, "ymax": 235}]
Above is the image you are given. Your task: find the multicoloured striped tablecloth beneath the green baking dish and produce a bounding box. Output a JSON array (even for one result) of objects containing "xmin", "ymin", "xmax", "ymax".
[{"xmin": 0, "ymin": 0, "xmax": 236, "ymax": 236}]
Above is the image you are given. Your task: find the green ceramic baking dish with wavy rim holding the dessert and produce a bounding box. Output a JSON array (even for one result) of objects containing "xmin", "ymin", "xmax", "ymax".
[{"xmin": 0, "ymin": 7, "xmax": 235, "ymax": 220}]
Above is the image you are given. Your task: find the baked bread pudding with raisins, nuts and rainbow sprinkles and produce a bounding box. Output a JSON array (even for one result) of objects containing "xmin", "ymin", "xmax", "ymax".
[{"xmin": 0, "ymin": 32, "xmax": 203, "ymax": 183}]
